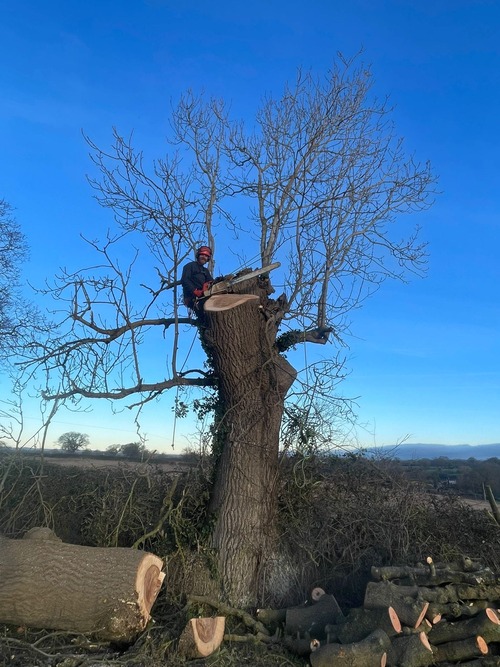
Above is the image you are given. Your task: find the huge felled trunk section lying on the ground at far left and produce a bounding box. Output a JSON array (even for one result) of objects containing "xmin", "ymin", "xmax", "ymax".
[{"xmin": 0, "ymin": 533, "xmax": 165, "ymax": 642}]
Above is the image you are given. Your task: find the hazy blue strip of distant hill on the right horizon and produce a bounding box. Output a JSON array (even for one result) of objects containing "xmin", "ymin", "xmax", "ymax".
[{"xmin": 367, "ymin": 443, "xmax": 500, "ymax": 461}]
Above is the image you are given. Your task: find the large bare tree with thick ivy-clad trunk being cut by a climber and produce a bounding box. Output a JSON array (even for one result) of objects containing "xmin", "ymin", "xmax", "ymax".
[{"xmin": 27, "ymin": 58, "xmax": 434, "ymax": 604}]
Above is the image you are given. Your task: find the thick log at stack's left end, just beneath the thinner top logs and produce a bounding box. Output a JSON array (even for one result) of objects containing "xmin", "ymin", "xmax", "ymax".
[{"xmin": 364, "ymin": 581, "xmax": 429, "ymax": 628}]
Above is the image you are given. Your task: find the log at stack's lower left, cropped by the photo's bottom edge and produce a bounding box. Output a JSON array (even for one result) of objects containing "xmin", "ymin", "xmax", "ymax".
[{"xmin": 310, "ymin": 630, "xmax": 391, "ymax": 667}]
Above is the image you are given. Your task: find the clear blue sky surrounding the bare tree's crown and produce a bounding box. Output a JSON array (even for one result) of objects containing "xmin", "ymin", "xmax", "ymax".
[{"xmin": 0, "ymin": 0, "xmax": 500, "ymax": 450}]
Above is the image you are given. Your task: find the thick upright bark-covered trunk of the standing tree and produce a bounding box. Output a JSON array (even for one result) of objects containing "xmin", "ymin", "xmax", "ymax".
[{"xmin": 202, "ymin": 279, "xmax": 296, "ymax": 606}]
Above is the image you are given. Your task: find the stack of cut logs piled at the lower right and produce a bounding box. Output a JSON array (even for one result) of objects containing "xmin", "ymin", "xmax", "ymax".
[{"xmin": 258, "ymin": 558, "xmax": 500, "ymax": 667}]
